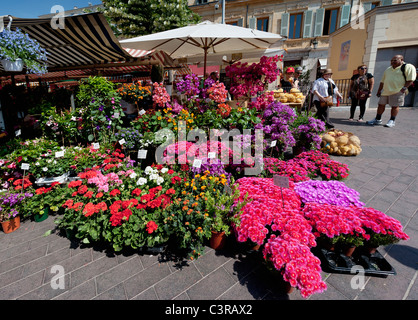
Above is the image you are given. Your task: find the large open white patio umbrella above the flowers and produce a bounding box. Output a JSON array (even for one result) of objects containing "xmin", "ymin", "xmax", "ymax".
[{"xmin": 120, "ymin": 21, "xmax": 282, "ymax": 76}]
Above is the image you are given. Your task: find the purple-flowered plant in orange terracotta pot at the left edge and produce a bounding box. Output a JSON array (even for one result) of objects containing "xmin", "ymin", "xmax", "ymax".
[{"xmin": 0, "ymin": 192, "xmax": 32, "ymax": 233}]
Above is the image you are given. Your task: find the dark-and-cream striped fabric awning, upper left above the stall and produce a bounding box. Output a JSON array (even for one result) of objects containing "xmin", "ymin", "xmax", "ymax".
[{"xmin": 3, "ymin": 12, "xmax": 134, "ymax": 71}]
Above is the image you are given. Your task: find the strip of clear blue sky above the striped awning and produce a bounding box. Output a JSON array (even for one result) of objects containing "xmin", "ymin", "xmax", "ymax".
[{"xmin": 0, "ymin": 0, "xmax": 102, "ymax": 18}]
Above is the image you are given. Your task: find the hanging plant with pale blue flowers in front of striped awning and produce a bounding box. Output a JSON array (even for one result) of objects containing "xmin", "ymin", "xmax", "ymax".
[{"xmin": 0, "ymin": 28, "xmax": 47, "ymax": 74}]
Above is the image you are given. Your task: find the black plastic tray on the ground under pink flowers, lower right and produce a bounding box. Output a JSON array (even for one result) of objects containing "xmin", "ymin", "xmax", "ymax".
[{"xmin": 313, "ymin": 248, "xmax": 396, "ymax": 278}]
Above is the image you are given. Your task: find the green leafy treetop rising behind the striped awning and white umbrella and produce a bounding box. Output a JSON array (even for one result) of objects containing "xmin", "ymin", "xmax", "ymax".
[{"xmin": 102, "ymin": 0, "xmax": 200, "ymax": 38}]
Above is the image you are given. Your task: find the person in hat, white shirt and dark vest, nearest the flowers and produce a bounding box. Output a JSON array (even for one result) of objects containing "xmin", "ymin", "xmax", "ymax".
[{"xmin": 312, "ymin": 69, "xmax": 342, "ymax": 129}]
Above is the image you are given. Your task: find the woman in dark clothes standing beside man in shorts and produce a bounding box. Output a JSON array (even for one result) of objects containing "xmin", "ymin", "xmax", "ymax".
[{"xmin": 349, "ymin": 65, "xmax": 374, "ymax": 122}]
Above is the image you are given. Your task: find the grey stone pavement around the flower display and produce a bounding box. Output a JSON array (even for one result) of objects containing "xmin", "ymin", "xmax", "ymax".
[{"xmin": 0, "ymin": 108, "xmax": 418, "ymax": 301}]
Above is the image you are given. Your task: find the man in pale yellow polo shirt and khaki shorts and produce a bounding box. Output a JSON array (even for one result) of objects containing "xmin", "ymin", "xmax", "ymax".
[{"xmin": 366, "ymin": 55, "xmax": 417, "ymax": 128}]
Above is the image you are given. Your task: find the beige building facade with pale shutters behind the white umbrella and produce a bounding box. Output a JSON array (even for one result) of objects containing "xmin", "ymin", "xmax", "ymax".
[{"xmin": 189, "ymin": 0, "xmax": 413, "ymax": 80}]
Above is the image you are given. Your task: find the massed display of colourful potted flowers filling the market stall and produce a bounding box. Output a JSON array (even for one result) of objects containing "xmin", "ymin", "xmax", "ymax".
[{"xmin": 0, "ymin": 21, "xmax": 408, "ymax": 298}]
